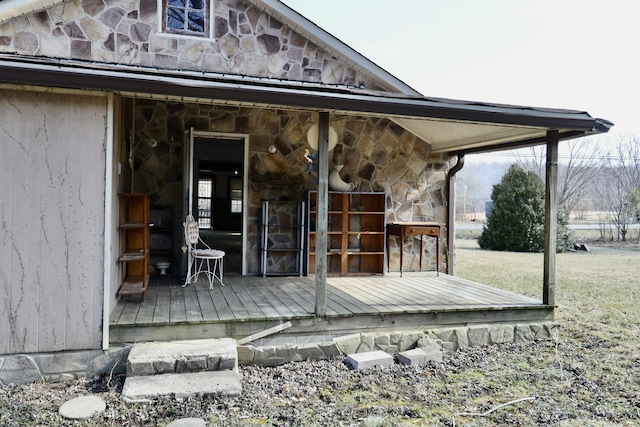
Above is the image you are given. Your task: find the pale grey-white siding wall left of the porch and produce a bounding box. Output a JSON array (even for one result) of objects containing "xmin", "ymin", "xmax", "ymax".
[{"xmin": 0, "ymin": 89, "xmax": 107, "ymax": 354}]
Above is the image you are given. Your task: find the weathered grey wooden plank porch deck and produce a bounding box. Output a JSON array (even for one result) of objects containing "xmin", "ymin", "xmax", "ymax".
[{"xmin": 110, "ymin": 272, "xmax": 553, "ymax": 344}]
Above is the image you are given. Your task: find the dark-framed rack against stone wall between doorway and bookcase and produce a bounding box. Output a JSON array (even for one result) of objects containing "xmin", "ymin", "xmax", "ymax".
[{"xmin": 260, "ymin": 200, "xmax": 307, "ymax": 277}]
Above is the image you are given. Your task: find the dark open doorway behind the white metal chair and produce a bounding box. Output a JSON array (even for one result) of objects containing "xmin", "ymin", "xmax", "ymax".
[{"xmin": 190, "ymin": 134, "xmax": 245, "ymax": 275}]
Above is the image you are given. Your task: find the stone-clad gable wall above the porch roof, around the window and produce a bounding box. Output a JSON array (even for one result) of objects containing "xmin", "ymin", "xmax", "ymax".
[{"xmin": 0, "ymin": 0, "xmax": 392, "ymax": 90}]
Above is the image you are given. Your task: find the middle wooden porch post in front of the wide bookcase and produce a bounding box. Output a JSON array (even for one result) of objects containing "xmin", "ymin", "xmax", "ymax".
[{"xmin": 315, "ymin": 112, "xmax": 329, "ymax": 317}]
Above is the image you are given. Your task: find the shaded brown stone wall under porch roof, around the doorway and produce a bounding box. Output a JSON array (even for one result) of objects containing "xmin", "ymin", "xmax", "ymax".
[{"xmin": 134, "ymin": 100, "xmax": 449, "ymax": 273}]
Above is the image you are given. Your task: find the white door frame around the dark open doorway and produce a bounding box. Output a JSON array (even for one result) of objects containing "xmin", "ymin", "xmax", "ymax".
[{"xmin": 183, "ymin": 128, "xmax": 249, "ymax": 276}]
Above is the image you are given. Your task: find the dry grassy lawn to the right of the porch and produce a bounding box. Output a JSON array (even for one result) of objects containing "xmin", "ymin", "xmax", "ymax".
[{"xmin": 456, "ymin": 240, "xmax": 640, "ymax": 426}]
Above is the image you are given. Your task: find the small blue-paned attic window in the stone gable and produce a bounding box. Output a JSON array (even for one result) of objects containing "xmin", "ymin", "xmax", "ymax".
[{"xmin": 163, "ymin": 0, "xmax": 209, "ymax": 36}]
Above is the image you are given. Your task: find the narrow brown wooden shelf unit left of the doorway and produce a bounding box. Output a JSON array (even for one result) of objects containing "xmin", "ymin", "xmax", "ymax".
[{"xmin": 118, "ymin": 194, "xmax": 149, "ymax": 301}]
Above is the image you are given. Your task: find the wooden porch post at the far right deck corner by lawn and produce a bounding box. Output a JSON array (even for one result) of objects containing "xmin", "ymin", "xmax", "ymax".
[{"xmin": 542, "ymin": 130, "xmax": 558, "ymax": 305}]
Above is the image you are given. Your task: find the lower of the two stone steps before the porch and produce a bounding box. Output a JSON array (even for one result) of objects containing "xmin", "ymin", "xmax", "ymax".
[{"xmin": 122, "ymin": 370, "xmax": 242, "ymax": 402}]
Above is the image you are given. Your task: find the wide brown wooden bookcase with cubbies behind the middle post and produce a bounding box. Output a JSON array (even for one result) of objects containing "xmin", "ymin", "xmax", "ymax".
[{"xmin": 307, "ymin": 191, "xmax": 386, "ymax": 276}]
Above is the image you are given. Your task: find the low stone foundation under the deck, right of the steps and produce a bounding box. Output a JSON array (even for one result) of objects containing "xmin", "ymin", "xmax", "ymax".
[{"xmin": 238, "ymin": 322, "xmax": 558, "ymax": 366}]
